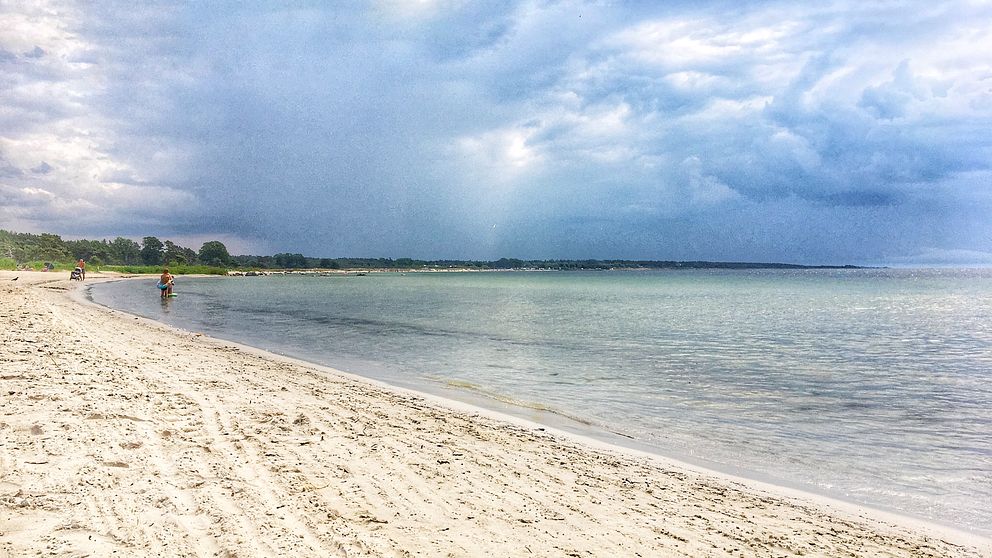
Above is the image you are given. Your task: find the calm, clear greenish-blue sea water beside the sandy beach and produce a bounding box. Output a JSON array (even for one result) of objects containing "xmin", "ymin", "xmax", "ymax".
[{"xmin": 91, "ymin": 270, "xmax": 992, "ymax": 534}]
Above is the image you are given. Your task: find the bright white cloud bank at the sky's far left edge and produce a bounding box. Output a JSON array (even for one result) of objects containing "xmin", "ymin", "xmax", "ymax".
[{"xmin": 0, "ymin": 3, "xmax": 203, "ymax": 236}]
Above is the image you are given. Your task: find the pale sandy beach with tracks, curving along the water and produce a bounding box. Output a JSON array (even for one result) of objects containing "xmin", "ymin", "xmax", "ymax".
[{"xmin": 0, "ymin": 272, "xmax": 992, "ymax": 558}]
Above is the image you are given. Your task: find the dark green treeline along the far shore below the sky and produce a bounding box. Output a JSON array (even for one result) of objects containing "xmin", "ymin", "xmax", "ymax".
[{"xmin": 0, "ymin": 230, "xmax": 854, "ymax": 270}]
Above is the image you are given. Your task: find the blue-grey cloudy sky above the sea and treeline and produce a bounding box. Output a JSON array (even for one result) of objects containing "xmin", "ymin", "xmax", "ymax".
[{"xmin": 0, "ymin": 0, "xmax": 992, "ymax": 265}]
